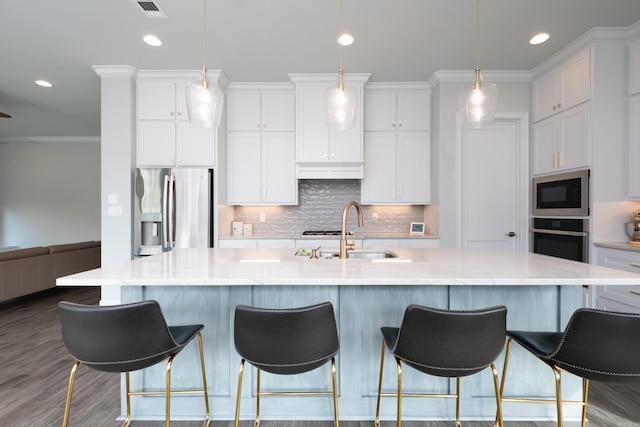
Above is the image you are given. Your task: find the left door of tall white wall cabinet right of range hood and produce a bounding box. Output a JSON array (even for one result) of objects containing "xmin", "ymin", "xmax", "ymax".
[{"xmin": 362, "ymin": 132, "xmax": 397, "ymax": 204}]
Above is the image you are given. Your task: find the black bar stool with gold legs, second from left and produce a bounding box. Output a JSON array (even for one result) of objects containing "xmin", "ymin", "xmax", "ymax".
[{"xmin": 233, "ymin": 302, "xmax": 340, "ymax": 427}]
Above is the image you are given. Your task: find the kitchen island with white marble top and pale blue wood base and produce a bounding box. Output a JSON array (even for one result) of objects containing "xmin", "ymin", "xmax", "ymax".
[{"xmin": 57, "ymin": 248, "xmax": 640, "ymax": 420}]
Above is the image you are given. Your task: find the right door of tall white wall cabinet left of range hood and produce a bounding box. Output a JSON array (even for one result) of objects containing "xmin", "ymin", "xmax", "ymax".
[{"xmin": 262, "ymin": 132, "xmax": 298, "ymax": 205}]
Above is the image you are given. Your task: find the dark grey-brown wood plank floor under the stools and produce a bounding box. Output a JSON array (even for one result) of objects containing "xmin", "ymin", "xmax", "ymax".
[{"xmin": 0, "ymin": 288, "xmax": 640, "ymax": 427}]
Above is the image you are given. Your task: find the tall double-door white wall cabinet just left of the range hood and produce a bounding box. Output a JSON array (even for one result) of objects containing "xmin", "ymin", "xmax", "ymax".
[{"xmin": 227, "ymin": 132, "xmax": 298, "ymax": 205}]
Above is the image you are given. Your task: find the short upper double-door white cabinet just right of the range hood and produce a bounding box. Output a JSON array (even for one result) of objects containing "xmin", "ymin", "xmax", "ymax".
[{"xmin": 364, "ymin": 83, "xmax": 431, "ymax": 131}]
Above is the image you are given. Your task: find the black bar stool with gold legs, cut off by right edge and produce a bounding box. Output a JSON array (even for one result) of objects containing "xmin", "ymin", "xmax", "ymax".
[{"xmin": 500, "ymin": 308, "xmax": 640, "ymax": 427}]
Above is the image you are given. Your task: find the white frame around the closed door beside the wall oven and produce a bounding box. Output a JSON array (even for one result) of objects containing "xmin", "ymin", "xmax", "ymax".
[{"xmin": 456, "ymin": 111, "xmax": 531, "ymax": 252}]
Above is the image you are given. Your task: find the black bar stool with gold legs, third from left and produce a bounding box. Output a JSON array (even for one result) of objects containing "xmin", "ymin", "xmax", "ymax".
[{"xmin": 375, "ymin": 304, "xmax": 507, "ymax": 427}]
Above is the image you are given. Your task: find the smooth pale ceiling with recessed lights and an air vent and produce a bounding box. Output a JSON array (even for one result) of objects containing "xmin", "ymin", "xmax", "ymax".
[{"xmin": 0, "ymin": 0, "xmax": 640, "ymax": 142}]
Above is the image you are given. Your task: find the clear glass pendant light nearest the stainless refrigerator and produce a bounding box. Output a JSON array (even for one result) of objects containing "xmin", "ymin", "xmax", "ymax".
[{"xmin": 186, "ymin": 0, "xmax": 224, "ymax": 128}]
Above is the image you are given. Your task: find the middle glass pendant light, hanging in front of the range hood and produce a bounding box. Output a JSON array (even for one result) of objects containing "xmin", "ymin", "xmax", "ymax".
[{"xmin": 324, "ymin": 0, "xmax": 359, "ymax": 130}]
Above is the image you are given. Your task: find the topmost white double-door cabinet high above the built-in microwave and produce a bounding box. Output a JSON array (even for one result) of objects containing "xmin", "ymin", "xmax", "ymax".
[{"xmin": 533, "ymin": 48, "xmax": 591, "ymax": 122}]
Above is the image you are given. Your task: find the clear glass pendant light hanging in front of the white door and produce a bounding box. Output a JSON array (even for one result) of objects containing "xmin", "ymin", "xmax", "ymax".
[{"xmin": 459, "ymin": 0, "xmax": 498, "ymax": 129}]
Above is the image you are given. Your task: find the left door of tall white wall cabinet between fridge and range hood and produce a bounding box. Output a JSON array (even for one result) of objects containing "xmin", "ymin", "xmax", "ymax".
[{"xmin": 227, "ymin": 132, "xmax": 262, "ymax": 205}]
